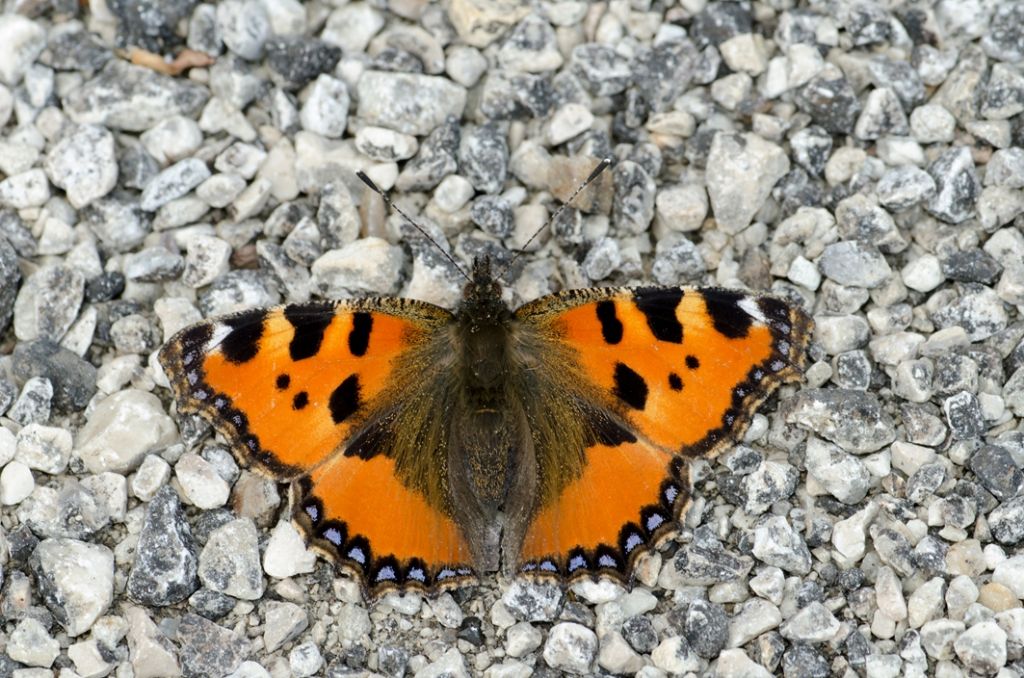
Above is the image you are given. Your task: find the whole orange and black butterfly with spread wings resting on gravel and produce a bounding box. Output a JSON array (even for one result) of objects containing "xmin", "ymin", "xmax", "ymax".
[{"xmin": 159, "ymin": 171, "xmax": 810, "ymax": 597}]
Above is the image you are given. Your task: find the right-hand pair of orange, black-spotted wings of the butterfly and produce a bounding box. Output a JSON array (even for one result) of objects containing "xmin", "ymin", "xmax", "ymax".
[{"xmin": 516, "ymin": 288, "xmax": 810, "ymax": 580}]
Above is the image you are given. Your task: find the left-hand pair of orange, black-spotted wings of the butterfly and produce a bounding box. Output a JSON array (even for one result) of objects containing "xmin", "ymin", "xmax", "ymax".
[{"xmin": 160, "ymin": 299, "xmax": 472, "ymax": 593}]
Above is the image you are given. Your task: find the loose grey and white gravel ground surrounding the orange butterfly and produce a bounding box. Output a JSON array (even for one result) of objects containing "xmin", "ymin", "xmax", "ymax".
[{"xmin": 0, "ymin": 0, "xmax": 1024, "ymax": 678}]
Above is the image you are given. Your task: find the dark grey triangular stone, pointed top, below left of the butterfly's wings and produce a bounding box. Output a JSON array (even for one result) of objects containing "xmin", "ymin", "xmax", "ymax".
[{"xmin": 127, "ymin": 486, "xmax": 198, "ymax": 606}]
